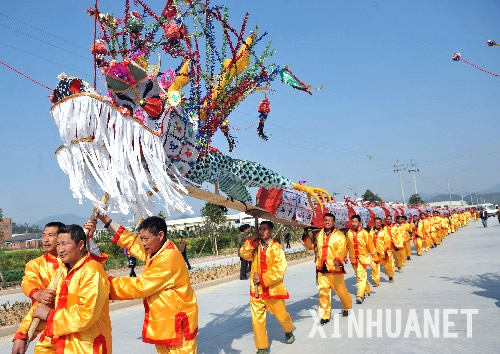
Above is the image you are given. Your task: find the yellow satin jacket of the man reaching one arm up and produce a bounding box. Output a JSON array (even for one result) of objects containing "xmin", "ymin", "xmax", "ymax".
[{"xmin": 110, "ymin": 226, "xmax": 198, "ymax": 346}]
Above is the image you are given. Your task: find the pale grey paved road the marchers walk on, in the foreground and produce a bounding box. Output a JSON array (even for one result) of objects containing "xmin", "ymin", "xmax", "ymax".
[{"xmin": 0, "ymin": 221, "xmax": 500, "ymax": 354}]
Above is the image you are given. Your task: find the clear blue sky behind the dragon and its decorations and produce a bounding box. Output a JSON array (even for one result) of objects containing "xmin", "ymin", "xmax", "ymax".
[{"xmin": 0, "ymin": 0, "xmax": 500, "ymax": 222}]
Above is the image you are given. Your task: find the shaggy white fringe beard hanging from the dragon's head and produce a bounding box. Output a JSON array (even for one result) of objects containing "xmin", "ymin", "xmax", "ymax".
[{"xmin": 52, "ymin": 95, "xmax": 192, "ymax": 216}]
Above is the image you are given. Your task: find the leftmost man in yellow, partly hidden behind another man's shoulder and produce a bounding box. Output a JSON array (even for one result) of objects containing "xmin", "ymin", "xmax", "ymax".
[{"xmin": 21, "ymin": 222, "xmax": 64, "ymax": 306}]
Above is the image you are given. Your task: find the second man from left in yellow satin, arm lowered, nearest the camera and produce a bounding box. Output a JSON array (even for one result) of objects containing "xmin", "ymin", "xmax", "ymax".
[{"xmin": 12, "ymin": 225, "xmax": 112, "ymax": 354}]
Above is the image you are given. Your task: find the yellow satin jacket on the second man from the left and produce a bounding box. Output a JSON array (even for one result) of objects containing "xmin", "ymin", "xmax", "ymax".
[{"xmin": 15, "ymin": 254, "xmax": 112, "ymax": 354}]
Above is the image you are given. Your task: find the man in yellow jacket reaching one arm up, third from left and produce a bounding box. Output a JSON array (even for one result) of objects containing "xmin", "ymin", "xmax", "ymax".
[{"xmin": 99, "ymin": 215, "xmax": 198, "ymax": 354}]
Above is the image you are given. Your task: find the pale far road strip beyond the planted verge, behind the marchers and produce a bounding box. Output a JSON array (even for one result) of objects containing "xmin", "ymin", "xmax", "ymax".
[{"xmin": 0, "ymin": 244, "xmax": 304, "ymax": 305}]
